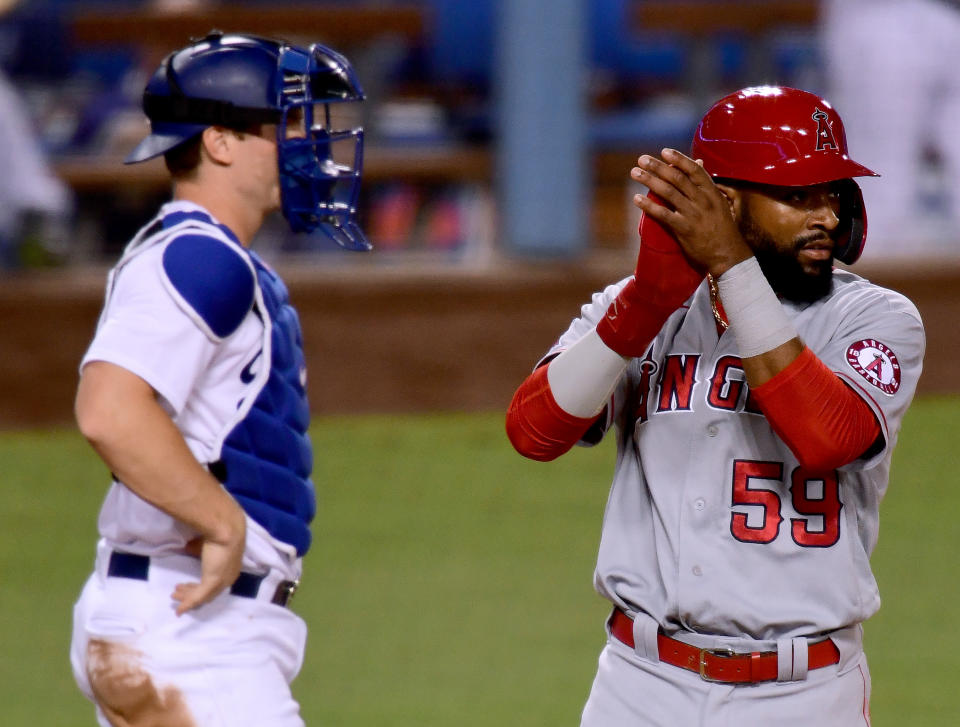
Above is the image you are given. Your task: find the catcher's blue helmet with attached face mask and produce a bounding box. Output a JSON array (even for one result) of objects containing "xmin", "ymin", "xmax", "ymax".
[{"xmin": 124, "ymin": 32, "xmax": 370, "ymax": 250}]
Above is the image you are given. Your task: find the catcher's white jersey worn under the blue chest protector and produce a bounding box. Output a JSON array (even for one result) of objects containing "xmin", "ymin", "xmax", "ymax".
[{"xmin": 81, "ymin": 201, "xmax": 300, "ymax": 580}]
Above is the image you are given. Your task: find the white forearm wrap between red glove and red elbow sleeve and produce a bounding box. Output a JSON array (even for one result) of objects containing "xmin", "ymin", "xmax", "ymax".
[{"xmin": 547, "ymin": 330, "xmax": 627, "ymax": 419}]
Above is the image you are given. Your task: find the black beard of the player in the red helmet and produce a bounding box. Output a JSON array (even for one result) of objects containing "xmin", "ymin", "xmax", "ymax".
[{"xmin": 739, "ymin": 210, "xmax": 833, "ymax": 303}]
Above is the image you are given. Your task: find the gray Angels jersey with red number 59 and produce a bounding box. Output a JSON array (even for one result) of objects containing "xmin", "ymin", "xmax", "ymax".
[{"xmin": 550, "ymin": 271, "xmax": 925, "ymax": 640}]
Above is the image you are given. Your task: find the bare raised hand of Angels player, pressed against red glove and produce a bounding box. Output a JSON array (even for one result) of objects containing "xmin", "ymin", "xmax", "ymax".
[{"xmin": 630, "ymin": 149, "xmax": 753, "ymax": 277}]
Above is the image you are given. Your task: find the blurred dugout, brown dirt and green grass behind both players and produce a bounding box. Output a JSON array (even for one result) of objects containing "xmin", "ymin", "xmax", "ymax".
[{"xmin": 0, "ymin": 0, "xmax": 960, "ymax": 727}]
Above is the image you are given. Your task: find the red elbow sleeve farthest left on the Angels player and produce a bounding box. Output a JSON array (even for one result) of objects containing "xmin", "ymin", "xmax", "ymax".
[{"xmin": 507, "ymin": 366, "xmax": 596, "ymax": 462}]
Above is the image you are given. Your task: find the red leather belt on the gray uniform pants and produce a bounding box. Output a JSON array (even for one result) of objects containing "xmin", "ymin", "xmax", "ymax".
[{"xmin": 610, "ymin": 608, "xmax": 840, "ymax": 684}]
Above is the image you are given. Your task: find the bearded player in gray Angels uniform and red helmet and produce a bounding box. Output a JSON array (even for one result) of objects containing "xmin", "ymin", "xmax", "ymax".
[{"xmin": 507, "ymin": 86, "xmax": 925, "ymax": 727}]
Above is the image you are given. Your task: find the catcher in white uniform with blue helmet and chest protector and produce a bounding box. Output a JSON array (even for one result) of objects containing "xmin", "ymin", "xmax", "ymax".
[{"xmin": 71, "ymin": 33, "xmax": 368, "ymax": 727}]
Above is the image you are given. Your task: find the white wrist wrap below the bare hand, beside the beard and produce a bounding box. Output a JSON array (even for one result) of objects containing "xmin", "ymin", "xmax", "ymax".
[{"xmin": 717, "ymin": 257, "xmax": 797, "ymax": 358}]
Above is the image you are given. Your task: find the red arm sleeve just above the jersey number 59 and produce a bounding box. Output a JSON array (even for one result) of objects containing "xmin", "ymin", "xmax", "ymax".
[{"xmin": 753, "ymin": 347, "xmax": 880, "ymax": 472}]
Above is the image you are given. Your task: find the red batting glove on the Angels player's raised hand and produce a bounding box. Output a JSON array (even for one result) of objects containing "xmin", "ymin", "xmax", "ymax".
[{"xmin": 597, "ymin": 192, "xmax": 705, "ymax": 357}]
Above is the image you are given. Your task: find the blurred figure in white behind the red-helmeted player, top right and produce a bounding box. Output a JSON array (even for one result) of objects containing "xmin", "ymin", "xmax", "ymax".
[{"xmin": 821, "ymin": 0, "xmax": 960, "ymax": 260}]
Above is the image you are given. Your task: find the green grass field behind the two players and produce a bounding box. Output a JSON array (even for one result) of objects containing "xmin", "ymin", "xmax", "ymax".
[{"xmin": 0, "ymin": 397, "xmax": 960, "ymax": 727}]
